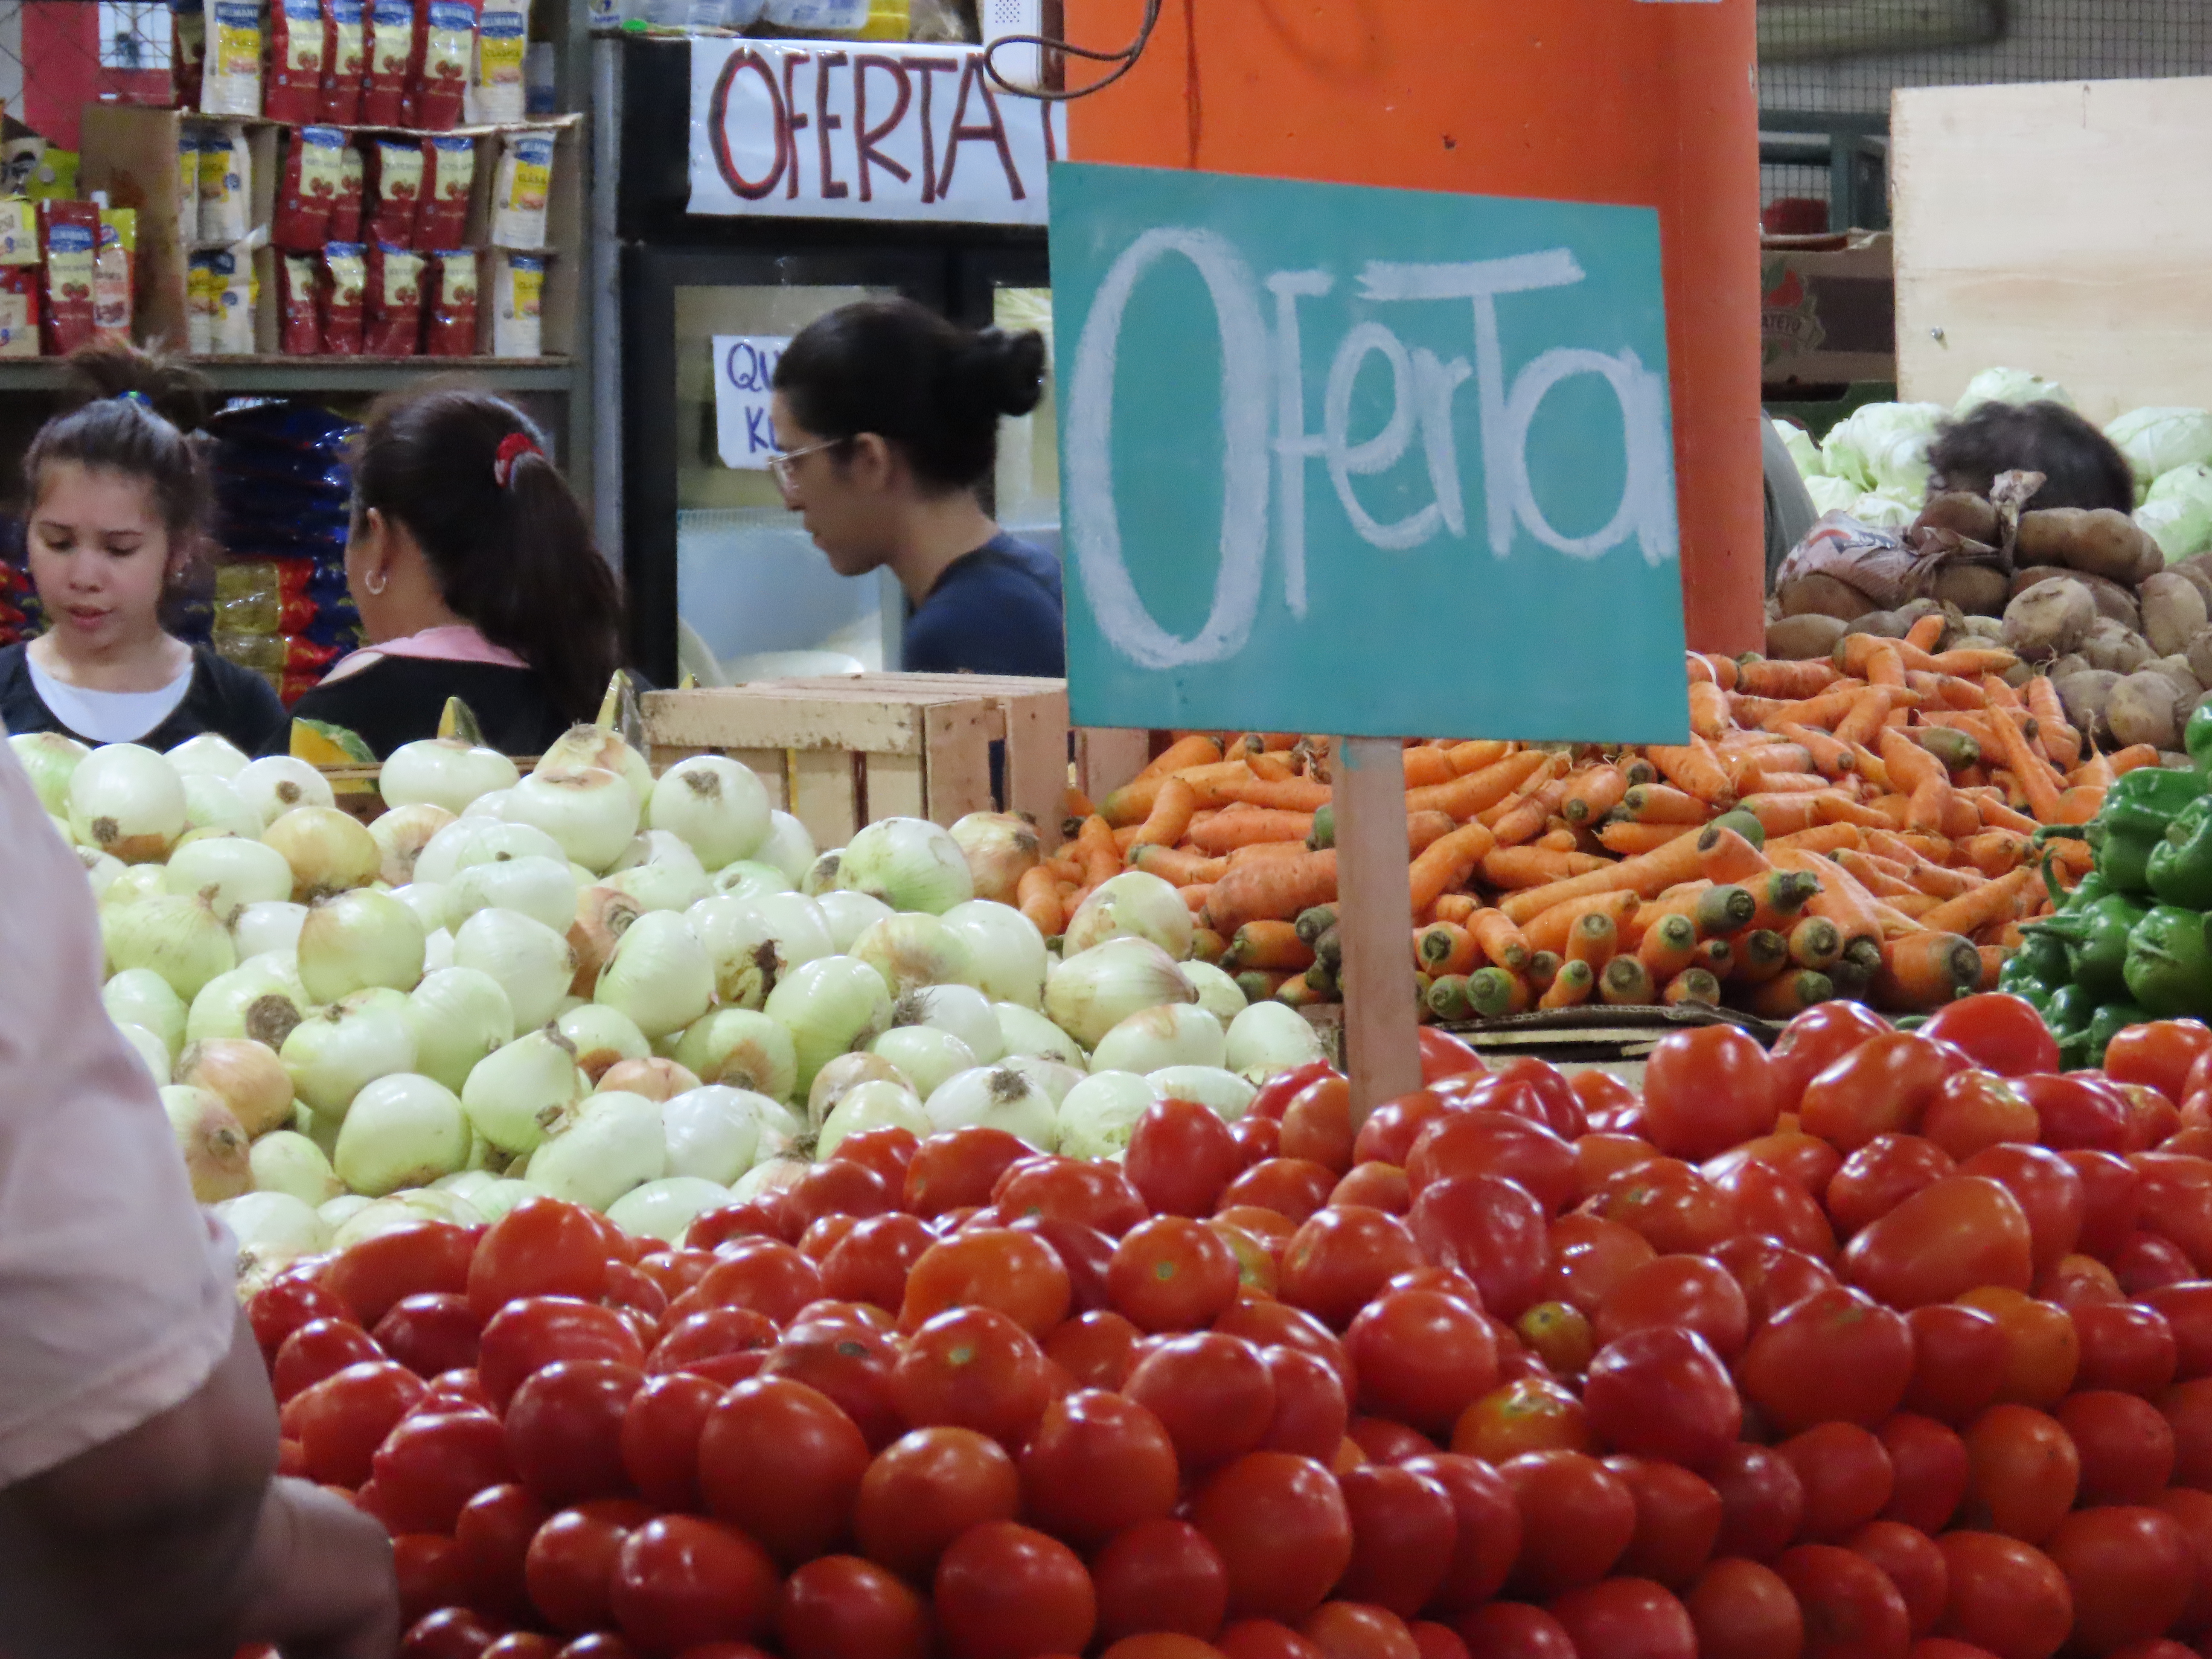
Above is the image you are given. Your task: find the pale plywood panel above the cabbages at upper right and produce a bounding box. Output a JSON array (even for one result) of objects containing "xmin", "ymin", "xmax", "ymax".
[{"xmin": 1891, "ymin": 77, "xmax": 2212, "ymax": 422}]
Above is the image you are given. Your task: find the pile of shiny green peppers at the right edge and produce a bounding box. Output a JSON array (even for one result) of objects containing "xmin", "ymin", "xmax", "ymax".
[{"xmin": 1997, "ymin": 708, "xmax": 2212, "ymax": 1066}]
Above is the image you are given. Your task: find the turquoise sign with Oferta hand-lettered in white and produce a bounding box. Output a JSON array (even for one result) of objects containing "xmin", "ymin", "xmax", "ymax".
[{"xmin": 1051, "ymin": 164, "xmax": 1688, "ymax": 743}]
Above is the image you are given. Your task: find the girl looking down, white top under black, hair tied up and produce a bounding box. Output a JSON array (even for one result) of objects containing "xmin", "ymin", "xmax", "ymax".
[{"xmin": 0, "ymin": 341, "xmax": 288, "ymax": 754}]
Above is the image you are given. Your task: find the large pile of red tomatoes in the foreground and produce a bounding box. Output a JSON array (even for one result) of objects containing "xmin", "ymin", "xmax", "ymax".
[{"xmin": 250, "ymin": 995, "xmax": 2212, "ymax": 1659}]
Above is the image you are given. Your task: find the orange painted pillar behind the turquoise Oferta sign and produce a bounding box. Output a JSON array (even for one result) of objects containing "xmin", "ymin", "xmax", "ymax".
[{"xmin": 1068, "ymin": 0, "xmax": 1765, "ymax": 652}]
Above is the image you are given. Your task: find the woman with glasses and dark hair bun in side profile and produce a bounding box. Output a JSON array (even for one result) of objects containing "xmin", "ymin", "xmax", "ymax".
[{"xmin": 772, "ymin": 299, "xmax": 1066, "ymax": 679}]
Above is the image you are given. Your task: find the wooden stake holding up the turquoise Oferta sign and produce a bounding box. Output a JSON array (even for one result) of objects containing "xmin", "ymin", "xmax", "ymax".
[{"xmin": 1334, "ymin": 736, "xmax": 1420, "ymax": 1126}]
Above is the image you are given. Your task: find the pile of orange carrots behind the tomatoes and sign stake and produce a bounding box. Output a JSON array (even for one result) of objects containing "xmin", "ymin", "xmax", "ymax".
[{"xmin": 1020, "ymin": 615, "xmax": 2132, "ymax": 1020}]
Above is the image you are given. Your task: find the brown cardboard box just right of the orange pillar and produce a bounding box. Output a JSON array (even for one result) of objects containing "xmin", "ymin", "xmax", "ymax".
[{"xmin": 1758, "ymin": 230, "xmax": 1898, "ymax": 387}]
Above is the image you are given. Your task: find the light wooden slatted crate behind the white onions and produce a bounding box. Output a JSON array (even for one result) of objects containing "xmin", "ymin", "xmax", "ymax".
[{"xmin": 644, "ymin": 675, "xmax": 1144, "ymax": 847}]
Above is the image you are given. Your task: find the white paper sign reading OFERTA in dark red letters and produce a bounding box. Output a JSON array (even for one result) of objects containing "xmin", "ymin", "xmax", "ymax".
[{"xmin": 690, "ymin": 35, "xmax": 1066, "ymax": 226}]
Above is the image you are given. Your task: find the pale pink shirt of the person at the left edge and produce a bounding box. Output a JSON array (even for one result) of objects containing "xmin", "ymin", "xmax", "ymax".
[{"xmin": 0, "ymin": 743, "xmax": 237, "ymax": 1487}]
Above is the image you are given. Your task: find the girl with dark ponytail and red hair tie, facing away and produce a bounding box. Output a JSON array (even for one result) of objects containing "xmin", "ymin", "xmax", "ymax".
[{"xmin": 294, "ymin": 387, "xmax": 622, "ymax": 757}]
